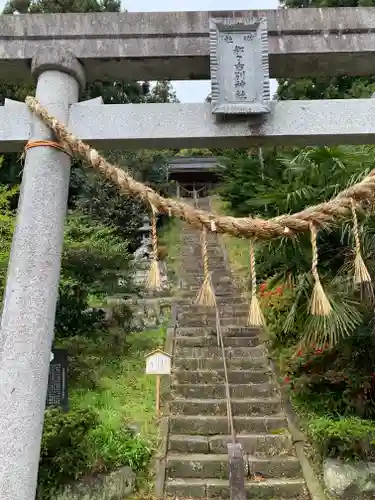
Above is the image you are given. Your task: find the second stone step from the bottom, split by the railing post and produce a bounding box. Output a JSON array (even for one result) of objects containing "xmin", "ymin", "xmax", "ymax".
[{"xmin": 166, "ymin": 453, "xmax": 301, "ymax": 479}]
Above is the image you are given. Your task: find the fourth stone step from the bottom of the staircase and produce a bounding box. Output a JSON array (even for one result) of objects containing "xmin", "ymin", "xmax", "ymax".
[{"xmin": 169, "ymin": 415, "xmax": 287, "ymax": 436}]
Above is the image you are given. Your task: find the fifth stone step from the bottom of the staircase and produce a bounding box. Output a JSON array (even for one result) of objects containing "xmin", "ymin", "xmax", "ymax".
[{"xmin": 169, "ymin": 397, "xmax": 282, "ymax": 416}]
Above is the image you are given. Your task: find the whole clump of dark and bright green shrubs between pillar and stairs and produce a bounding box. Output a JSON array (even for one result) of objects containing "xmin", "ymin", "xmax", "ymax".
[{"xmin": 37, "ymin": 408, "xmax": 152, "ymax": 500}]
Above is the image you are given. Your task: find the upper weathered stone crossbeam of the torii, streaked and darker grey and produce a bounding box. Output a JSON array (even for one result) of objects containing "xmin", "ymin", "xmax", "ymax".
[{"xmin": 0, "ymin": 7, "xmax": 375, "ymax": 82}]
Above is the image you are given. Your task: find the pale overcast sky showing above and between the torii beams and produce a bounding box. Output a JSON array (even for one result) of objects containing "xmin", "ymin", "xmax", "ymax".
[{"xmin": 0, "ymin": 0, "xmax": 278, "ymax": 102}]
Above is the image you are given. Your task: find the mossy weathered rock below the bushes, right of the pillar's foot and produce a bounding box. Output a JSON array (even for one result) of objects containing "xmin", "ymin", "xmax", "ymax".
[{"xmin": 55, "ymin": 467, "xmax": 135, "ymax": 500}]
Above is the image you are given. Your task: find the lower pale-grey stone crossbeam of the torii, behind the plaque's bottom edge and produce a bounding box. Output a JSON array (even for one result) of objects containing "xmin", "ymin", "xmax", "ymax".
[{"xmin": 0, "ymin": 99, "xmax": 375, "ymax": 152}]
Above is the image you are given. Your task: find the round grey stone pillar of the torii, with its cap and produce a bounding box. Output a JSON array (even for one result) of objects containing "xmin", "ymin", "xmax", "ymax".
[{"xmin": 0, "ymin": 47, "xmax": 84, "ymax": 500}]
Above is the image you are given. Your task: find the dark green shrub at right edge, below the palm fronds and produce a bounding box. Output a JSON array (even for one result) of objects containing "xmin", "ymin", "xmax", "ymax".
[{"xmin": 286, "ymin": 329, "xmax": 375, "ymax": 419}]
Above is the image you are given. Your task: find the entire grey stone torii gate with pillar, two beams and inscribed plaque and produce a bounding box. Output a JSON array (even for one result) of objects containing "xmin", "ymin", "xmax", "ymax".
[{"xmin": 0, "ymin": 8, "xmax": 375, "ymax": 500}]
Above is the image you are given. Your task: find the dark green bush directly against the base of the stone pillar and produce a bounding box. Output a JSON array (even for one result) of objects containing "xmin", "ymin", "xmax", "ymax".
[{"xmin": 37, "ymin": 409, "xmax": 97, "ymax": 500}]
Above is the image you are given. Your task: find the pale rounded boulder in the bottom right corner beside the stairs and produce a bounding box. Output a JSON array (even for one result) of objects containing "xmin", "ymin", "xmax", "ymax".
[{"xmin": 324, "ymin": 459, "xmax": 375, "ymax": 500}]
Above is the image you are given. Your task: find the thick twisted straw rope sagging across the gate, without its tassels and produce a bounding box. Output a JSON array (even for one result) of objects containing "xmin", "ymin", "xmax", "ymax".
[{"xmin": 26, "ymin": 96, "xmax": 375, "ymax": 240}]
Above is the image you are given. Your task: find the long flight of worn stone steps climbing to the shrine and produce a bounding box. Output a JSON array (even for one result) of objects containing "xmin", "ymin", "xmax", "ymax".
[{"xmin": 165, "ymin": 198, "xmax": 309, "ymax": 500}]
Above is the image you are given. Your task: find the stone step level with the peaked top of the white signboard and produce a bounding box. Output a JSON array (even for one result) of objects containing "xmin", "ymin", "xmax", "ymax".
[{"xmin": 174, "ymin": 344, "xmax": 266, "ymax": 359}]
